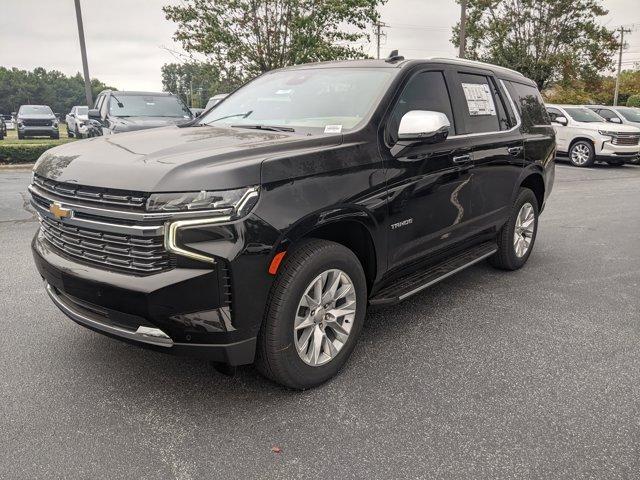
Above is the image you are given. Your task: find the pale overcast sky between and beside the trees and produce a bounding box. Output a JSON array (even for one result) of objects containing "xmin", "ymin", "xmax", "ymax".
[{"xmin": 0, "ymin": 0, "xmax": 640, "ymax": 90}]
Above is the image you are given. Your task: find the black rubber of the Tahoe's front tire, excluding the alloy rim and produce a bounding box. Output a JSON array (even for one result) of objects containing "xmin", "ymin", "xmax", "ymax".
[{"xmin": 266, "ymin": 242, "xmax": 367, "ymax": 389}]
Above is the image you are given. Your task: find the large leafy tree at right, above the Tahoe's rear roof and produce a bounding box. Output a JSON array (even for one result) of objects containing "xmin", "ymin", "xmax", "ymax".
[{"xmin": 452, "ymin": 0, "xmax": 618, "ymax": 89}]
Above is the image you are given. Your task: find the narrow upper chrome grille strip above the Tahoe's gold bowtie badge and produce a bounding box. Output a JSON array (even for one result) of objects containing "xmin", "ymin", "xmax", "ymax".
[{"xmin": 33, "ymin": 175, "xmax": 147, "ymax": 209}]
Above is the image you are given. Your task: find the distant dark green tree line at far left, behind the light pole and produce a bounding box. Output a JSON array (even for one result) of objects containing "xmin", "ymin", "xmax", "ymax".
[{"xmin": 0, "ymin": 67, "xmax": 110, "ymax": 116}]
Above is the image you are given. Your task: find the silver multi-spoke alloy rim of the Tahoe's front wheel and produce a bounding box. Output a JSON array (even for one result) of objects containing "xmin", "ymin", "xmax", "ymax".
[{"xmin": 293, "ymin": 269, "xmax": 356, "ymax": 367}]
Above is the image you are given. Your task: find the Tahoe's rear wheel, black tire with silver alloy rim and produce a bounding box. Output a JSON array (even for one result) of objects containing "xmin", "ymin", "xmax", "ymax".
[{"xmin": 489, "ymin": 188, "xmax": 539, "ymax": 270}]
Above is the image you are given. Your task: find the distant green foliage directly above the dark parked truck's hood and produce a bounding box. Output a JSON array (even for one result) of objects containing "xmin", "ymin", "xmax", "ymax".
[{"xmin": 162, "ymin": 62, "xmax": 243, "ymax": 108}]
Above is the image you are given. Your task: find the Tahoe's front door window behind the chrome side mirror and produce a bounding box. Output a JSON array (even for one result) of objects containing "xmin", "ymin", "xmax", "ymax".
[{"xmin": 389, "ymin": 71, "xmax": 455, "ymax": 143}]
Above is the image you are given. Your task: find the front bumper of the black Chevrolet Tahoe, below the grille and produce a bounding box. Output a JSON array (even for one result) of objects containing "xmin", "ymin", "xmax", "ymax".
[{"xmin": 32, "ymin": 232, "xmax": 256, "ymax": 365}]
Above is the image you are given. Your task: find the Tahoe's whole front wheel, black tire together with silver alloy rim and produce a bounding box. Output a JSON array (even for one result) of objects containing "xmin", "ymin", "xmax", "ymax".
[{"xmin": 256, "ymin": 239, "xmax": 367, "ymax": 390}]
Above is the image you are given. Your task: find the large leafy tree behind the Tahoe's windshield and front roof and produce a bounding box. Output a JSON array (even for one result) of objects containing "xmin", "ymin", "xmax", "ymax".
[{"xmin": 163, "ymin": 0, "xmax": 386, "ymax": 78}]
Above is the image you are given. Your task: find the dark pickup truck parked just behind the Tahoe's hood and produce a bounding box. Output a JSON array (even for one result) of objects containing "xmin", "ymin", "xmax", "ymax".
[{"xmin": 89, "ymin": 90, "xmax": 194, "ymax": 136}]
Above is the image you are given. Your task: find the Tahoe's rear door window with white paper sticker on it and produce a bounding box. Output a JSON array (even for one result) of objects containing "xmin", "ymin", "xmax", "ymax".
[{"xmin": 458, "ymin": 73, "xmax": 511, "ymax": 133}]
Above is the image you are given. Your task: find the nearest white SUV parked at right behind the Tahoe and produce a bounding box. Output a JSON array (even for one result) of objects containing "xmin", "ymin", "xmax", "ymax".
[{"xmin": 546, "ymin": 104, "xmax": 640, "ymax": 167}]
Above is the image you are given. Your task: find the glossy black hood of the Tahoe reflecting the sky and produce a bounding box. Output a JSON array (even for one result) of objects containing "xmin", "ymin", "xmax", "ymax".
[{"xmin": 34, "ymin": 126, "xmax": 342, "ymax": 192}]
